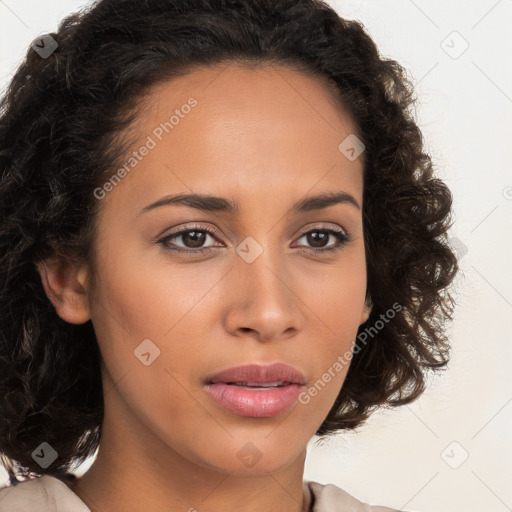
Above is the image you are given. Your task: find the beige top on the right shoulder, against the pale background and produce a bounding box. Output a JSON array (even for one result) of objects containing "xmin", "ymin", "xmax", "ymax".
[{"xmin": 304, "ymin": 480, "xmax": 408, "ymax": 512}]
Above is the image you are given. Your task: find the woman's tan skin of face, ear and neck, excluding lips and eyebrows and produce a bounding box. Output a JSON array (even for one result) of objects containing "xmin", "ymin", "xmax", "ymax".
[{"xmin": 39, "ymin": 64, "xmax": 369, "ymax": 512}]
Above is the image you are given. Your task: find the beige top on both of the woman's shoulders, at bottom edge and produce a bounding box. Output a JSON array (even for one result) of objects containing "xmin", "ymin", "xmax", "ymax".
[{"xmin": 0, "ymin": 475, "xmax": 406, "ymax": 512}]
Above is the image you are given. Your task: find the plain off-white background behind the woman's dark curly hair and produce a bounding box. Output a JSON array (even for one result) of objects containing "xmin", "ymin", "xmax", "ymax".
[{"xmin": 0, "ymin": 0, "xmax": 512, "ymax": 512}]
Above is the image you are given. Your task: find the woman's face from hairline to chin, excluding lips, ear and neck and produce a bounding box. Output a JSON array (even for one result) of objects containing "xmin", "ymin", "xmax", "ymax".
[{"xmin": 79, "ymin": 65, "xmax": 368, "ymax": 473}]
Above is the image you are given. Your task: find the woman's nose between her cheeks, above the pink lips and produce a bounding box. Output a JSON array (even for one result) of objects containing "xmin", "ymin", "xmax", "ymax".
[{"xmin": 224, "ymin": 244, "xmax": 304, "ymax": 342}]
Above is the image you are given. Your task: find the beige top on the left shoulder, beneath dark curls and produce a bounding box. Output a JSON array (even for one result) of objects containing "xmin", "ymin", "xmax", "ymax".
[{"xmin": 0, "ymin": 475, "xmax": 91, "ymax": 512}]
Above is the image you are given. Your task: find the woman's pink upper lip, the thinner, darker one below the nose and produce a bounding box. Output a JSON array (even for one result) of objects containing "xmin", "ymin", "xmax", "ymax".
[{"xmin": 206, "ymin": 363, "xmax": 305, "ymax": 385}]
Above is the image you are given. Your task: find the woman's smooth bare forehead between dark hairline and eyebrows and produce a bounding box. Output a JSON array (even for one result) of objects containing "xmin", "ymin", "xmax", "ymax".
[{"xmin": 101, "ymin": 64, "xmax": 362, "ymax": 217}]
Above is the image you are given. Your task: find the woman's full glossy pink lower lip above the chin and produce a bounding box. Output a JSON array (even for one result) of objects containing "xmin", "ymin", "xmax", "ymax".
[{"xmin": 206, "ymin": 382, "xmax": 304, "ymax": 418}]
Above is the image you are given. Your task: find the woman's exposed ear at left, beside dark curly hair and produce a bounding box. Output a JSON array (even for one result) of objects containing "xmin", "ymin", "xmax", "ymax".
[{"xmin": 36, "ymin": 259, "xmax": 91, "ymax": 324}]
